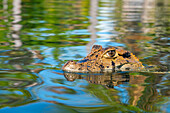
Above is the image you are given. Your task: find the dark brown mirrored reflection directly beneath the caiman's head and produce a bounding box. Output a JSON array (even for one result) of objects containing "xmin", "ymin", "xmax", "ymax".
[{"xmin": 64, "ymin": 72, "xmax": 130, "ymax": 88}]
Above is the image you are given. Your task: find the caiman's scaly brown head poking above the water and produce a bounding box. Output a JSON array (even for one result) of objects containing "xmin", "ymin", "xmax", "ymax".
[{"xmin": 62, "ymin": 45, "xmax": 144, "ymax": 73}]
